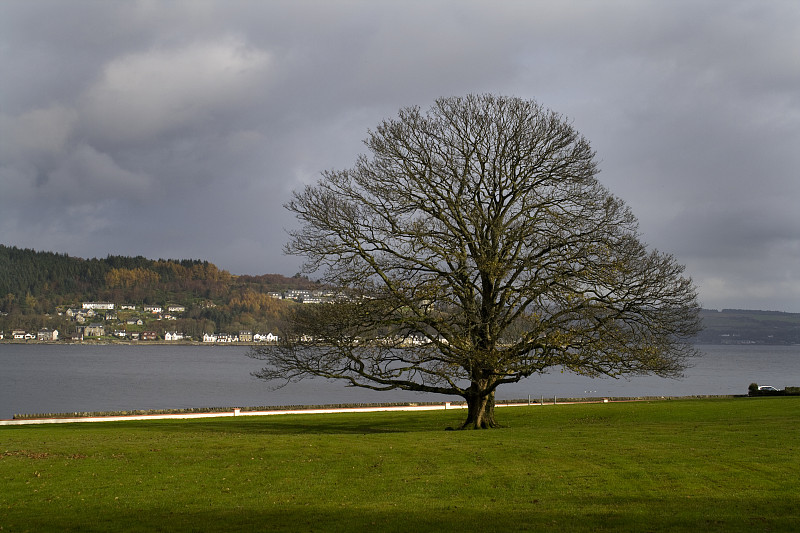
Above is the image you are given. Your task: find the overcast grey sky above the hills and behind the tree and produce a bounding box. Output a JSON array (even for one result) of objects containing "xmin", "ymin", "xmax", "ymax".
[{"xmin": 0, "ymin": 0, "xmax": 800, "ymax": 312}]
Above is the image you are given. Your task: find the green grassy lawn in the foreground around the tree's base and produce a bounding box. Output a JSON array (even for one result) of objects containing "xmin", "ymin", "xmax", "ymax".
[{"xmin": 0, "ymin": 397, "xmax": 800, "ymax": 532}]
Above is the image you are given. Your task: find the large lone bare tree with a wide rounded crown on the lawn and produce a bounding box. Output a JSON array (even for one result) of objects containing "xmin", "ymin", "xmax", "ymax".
[{"xmin": 250, "ymin": 95, "xmax": 700, "ymax": 428}]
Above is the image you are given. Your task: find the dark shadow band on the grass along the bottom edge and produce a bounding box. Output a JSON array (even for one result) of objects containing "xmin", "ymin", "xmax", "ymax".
[{"xmin": 9, "ymin": 495, "xmax": 797, "ymax": 533}]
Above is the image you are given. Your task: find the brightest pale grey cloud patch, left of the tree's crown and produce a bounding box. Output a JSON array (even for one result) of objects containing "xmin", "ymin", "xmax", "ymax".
[{"xmin": 82, "ymin": 38, "xmax": 270, "ymax": 142}]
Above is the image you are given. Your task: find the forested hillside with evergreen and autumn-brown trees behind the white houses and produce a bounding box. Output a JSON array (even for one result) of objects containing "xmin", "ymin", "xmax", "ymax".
[{"xmin": 0, "ymin": 245, "xmax": 318, "ymax": 330}]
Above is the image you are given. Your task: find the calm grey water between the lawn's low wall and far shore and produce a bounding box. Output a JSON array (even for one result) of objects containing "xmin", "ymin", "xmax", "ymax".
[{"xmin": 0, "ymin": 344, "xmax": 800, "ymax": 419}]
